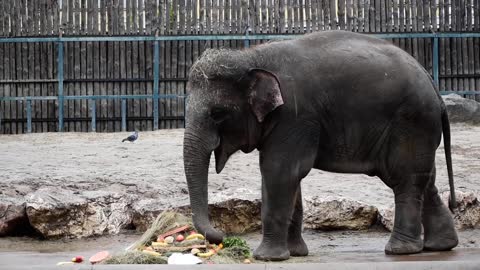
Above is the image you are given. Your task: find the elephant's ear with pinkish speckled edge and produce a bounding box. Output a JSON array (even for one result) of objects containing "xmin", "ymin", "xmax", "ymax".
[{"xmin": 248, "ymin": 69, "xmax": 283, "ymax": 123}]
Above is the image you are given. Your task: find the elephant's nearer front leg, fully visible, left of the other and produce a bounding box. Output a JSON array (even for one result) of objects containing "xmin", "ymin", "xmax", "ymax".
[{"xmin": 253, "ymin": 157, "xmax": 299, "ymax": 261}]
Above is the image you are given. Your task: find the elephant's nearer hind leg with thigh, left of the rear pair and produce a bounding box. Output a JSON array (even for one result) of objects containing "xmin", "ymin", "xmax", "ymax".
[{"xmin": 381, "ymin": 131, "xmax": 435, "ymax": 255}]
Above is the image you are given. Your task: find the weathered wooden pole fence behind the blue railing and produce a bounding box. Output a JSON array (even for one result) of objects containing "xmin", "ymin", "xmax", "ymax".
[{"xmin": 0, "ymin": 0, "xmax": 480, "ymax": 134}]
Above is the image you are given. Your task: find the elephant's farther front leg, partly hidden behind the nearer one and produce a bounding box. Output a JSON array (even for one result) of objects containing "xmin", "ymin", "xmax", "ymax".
[{"xmin": 287, "ymin": 186, "xmax": 308, "ymax": 256}]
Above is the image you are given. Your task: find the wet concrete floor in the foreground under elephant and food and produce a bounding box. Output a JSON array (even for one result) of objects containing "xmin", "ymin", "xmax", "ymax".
[{"xmin": 0, "ymin": 230, "xmax": 480, "ymax": 270}]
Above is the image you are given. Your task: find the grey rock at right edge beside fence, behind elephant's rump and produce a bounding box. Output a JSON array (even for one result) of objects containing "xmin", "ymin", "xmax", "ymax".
[{"xmin": 442, "ymin": 94, "xmax": 480, "ymax": 124}]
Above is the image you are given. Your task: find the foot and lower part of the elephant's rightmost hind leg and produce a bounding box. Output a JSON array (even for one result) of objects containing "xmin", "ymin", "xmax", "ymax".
[{"xmin": 422, "ymin": 205, "xmax": 458, "ymax": 251}]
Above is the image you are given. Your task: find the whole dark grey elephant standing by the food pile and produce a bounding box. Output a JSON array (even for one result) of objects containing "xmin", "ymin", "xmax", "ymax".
[{"xmin": 184, "ymin": 31, "xmax": 458, "ymax": 260}]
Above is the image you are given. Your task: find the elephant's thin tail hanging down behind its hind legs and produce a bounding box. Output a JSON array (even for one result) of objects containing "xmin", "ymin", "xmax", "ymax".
[{"xmin": 442, "ymin": 105, "xmax": 457, "ymax": 212}]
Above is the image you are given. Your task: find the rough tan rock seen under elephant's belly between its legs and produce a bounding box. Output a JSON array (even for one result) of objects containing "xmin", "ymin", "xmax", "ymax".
[{"xmin": 304, "ymin": 196, "xmax": 378, "ymax": 230}]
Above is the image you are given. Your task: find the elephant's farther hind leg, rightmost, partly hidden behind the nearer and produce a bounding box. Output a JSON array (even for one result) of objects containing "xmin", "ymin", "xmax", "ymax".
[{"xmin": 422, "ymin": 168, "xmax": 458, "ymax": 251}]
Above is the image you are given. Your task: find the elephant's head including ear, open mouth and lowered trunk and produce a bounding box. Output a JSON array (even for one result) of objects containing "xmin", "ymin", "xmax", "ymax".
[{"xmin": 183, "ymin": 50, "xmax": 283, "ymax": 243}]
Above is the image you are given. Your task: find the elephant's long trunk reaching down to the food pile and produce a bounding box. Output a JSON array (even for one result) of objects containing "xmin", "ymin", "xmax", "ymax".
[{"xmin": 183, "ymin": 125, "xmax": 223, "ymax": 244}]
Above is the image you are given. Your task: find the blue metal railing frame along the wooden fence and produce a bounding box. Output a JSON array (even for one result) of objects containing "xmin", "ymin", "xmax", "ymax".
[{"xmin": 0, "ymin": 32, "xmax": 480, "ymax": 133}]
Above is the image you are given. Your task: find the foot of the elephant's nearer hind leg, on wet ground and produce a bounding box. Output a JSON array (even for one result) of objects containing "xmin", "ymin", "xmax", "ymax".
[{"xmin": 385, "ymin": 232, "xmax": 423, "ymax": 255}]
